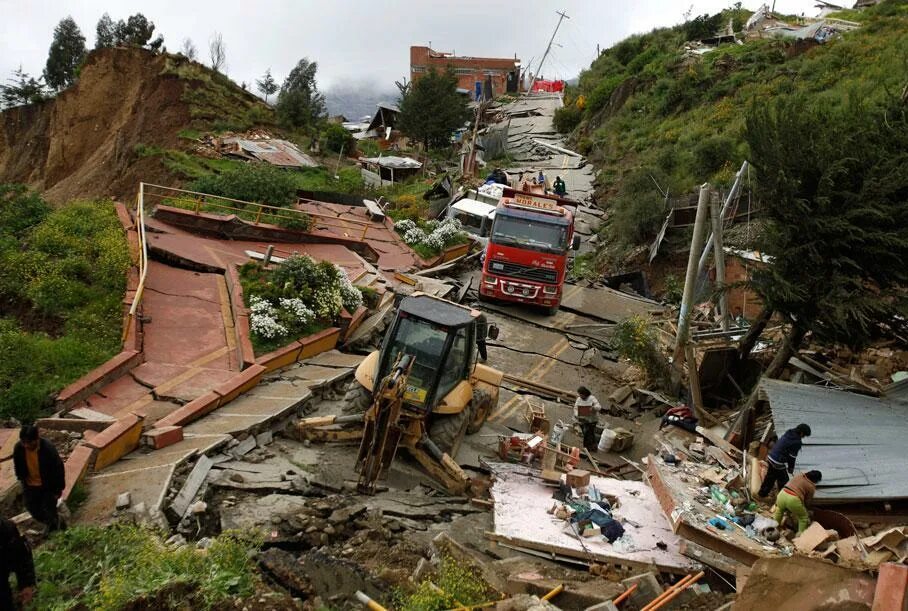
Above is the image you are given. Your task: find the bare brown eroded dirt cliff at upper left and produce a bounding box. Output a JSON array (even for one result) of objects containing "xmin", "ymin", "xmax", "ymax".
[{"xmin": 0, "ymin": 48, "xmax": 268, "ymax": 202}]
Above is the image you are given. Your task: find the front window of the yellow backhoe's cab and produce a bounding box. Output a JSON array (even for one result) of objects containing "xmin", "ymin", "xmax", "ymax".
[{"xmin": 381, "ymin": 318, "xmax": 448, "ymax": 404}]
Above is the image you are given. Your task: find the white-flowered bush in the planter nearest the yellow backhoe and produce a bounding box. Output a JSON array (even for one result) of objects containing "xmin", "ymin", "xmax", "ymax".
[{"xmin": 240, "ymin": 255, "xmax": 363, "ymax": 348}]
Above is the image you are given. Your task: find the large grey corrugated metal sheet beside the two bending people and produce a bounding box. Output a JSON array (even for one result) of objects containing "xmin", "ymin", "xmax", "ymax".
[{"xmin": 761, "ymin": 380, "xmax": 908, "ymax": 503}]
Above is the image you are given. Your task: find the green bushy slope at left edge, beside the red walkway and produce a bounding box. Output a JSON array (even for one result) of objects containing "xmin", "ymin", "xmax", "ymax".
[{"xmin": 0, "ymin": 185, "xmax": 130, "ymax": 420}]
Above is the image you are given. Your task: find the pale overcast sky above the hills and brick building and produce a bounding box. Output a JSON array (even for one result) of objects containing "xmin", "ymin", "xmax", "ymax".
[{"xmin": 0, "ymin": 0, "xmax": 816, "ymax": 91}]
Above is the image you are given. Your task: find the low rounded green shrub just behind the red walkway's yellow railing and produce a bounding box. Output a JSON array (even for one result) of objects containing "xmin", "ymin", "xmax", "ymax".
[{"xmin": 190, "ymin": 162, "xmax": 296, "ymax": 207}]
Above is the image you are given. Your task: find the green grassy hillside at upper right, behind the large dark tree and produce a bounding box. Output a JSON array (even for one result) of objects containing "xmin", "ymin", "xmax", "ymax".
[{"xmin": 556, "ymin": 0, "xmax": 908, "ymax": 256}]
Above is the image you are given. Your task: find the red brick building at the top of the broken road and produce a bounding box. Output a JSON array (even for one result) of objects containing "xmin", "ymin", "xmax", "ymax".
[{"xmin": 410, "ymin": 47, "xmax": 520, "ymax": 97}]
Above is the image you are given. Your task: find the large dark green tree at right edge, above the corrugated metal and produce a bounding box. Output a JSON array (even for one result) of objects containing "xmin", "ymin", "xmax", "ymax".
[{"xmin": 746, "ymin": 98, "xmax": 908, "ymax": 354}]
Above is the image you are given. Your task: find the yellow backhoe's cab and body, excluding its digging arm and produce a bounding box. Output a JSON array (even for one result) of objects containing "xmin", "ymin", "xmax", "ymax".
[{"xmin": 356, "ymin": 293, "xmax": 502, "ymax": 456}]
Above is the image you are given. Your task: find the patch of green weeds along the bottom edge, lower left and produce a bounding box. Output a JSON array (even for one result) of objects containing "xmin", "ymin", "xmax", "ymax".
[{"xmin": 33, "ymin": 524, "xmax": 259, "ymax": 611}]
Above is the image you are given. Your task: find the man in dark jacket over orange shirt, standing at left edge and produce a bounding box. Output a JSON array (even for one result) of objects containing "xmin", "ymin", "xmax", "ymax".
[{"xmin": 13, "ymin": 424, "xmax": 66, "ymax": 531}]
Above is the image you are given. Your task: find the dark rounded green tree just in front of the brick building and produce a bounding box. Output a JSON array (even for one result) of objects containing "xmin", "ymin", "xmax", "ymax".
[{"xmin": 398, "ymin": 68, "xmax": 470, "ymax": 149}]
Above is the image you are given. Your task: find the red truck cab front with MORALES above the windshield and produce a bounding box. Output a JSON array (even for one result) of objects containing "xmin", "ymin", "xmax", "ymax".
[{"xmin": 479, "ymin": 187, "xmax": 580, "ymax": 314}]
